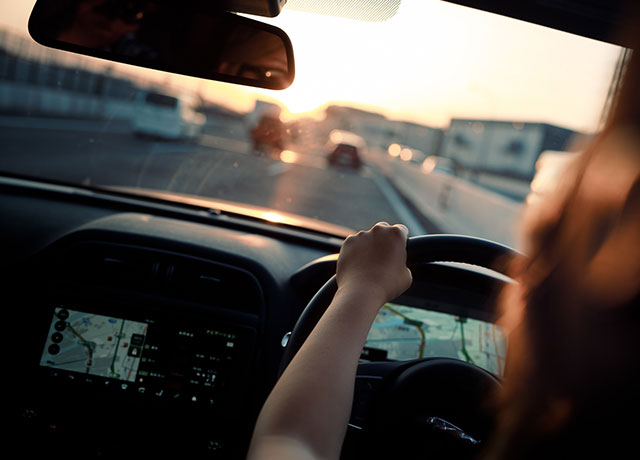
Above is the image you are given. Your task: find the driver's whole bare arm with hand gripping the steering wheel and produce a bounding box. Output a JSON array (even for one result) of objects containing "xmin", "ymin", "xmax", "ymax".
[{"xmin": 248, "ymin": 223, "xmax": 412, "ymax": 460}]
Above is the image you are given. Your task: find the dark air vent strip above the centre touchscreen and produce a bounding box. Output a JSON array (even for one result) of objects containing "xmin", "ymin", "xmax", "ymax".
[{"xmin": 57, "ymin": 242, "xmax": 262, "ymax": 314}]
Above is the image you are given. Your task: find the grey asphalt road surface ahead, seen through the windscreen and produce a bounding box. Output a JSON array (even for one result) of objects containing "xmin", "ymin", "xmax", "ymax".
[{"xmin": 0, "ymin": 115, "xmax": 422, "ymax": 233}]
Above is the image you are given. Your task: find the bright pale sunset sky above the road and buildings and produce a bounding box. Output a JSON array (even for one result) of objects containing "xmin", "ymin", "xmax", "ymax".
[{"xmin": 0, "ymin": 0, "xmax": 620, "ymax": 132}]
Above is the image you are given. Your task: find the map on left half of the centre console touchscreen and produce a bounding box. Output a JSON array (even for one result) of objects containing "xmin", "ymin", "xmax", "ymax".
[{"xmin": 40, "ymin": 308, "xmax": 148, "ymax": 382}]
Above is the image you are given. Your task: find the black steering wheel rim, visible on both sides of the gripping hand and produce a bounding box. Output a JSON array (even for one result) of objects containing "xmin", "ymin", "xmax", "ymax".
[{"xmin": 279, "ymin": 234, "xmax": 523, "ymax": 375}]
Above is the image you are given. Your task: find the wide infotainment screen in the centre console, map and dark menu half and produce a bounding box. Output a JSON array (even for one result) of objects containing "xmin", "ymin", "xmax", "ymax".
[{"xmin": 40, "ymin": 305, "xmax": 252, "ymax": 407}]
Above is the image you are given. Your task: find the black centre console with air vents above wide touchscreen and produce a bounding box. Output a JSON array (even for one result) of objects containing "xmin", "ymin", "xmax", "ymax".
[{"xmin": 12, "ymin": 239, "xmax": 262, "ymax": 459}]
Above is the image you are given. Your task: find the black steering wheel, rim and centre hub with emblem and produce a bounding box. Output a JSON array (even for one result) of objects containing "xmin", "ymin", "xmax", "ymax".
[{"xmin": 280, "ymin": 235, "xmax": 522, "ymax": 458}]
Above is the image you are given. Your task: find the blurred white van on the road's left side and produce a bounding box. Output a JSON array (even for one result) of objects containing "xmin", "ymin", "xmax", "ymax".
[{"xmin": 132, "ymin": 91, "xmax": 206, "ymax": 140}]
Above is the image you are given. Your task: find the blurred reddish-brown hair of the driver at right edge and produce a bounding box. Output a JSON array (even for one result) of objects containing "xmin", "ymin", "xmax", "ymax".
[{"xmin": 485, "ymin": 2, "xmax": 640, "ymax": 458}]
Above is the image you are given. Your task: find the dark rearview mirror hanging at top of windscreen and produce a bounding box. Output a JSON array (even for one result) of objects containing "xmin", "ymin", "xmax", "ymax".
[{"xmin": 29, "ymin": 0, "xmax": 294, "ymax": 89}]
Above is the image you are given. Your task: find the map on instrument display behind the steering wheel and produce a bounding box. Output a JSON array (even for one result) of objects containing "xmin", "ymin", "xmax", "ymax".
[{"xmin": 363, "ymin": 303, "xmax": 507, "ymax": 375}]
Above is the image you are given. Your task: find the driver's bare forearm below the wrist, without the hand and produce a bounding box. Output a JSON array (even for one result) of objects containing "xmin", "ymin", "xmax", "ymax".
[{"xmin": 249, "ymin": 290, "xmax": 383, "ymax": 459}]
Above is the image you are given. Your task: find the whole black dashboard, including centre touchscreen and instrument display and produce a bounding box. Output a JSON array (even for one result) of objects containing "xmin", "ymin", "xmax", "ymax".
[{"xmin": 0, "ymin": 175, "xmax": 506, "ymax": 458}]
